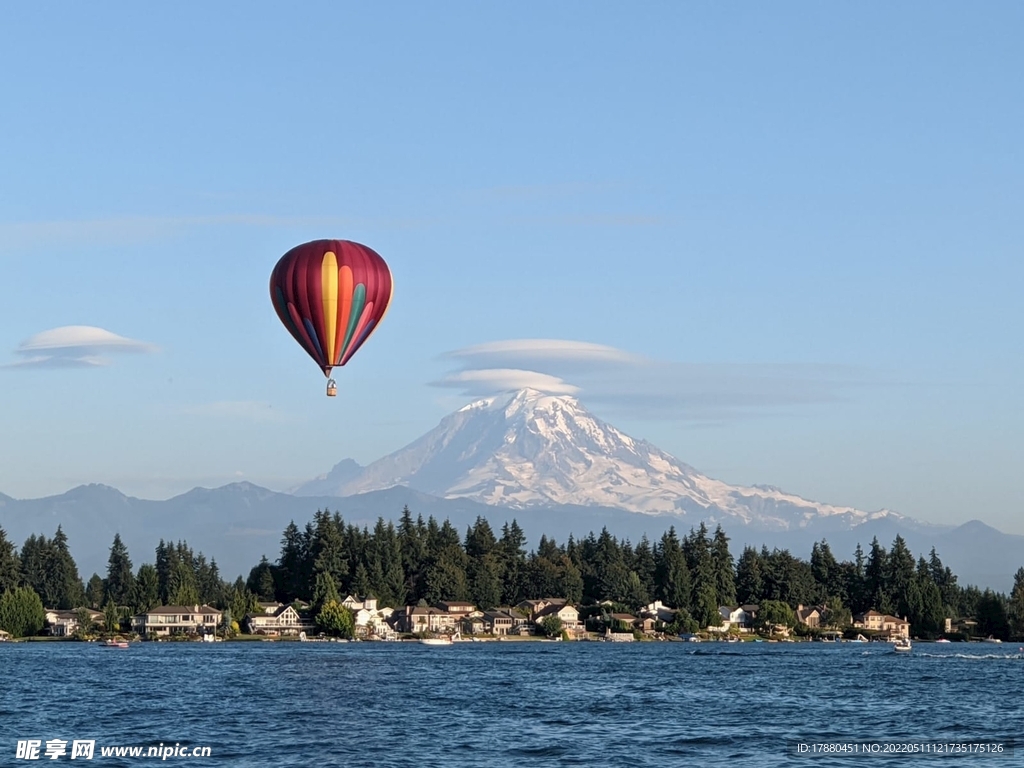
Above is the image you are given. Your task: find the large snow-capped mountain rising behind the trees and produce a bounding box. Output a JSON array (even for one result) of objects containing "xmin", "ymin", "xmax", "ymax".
[{"xmin": 292, "ymin": 389, "xmax": 898, "ymax": 529}]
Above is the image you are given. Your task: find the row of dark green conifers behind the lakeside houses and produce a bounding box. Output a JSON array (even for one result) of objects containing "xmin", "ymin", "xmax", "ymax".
[{"xmin": 0, "ymin": 507, "xmax": 1024, "ymax": 638}]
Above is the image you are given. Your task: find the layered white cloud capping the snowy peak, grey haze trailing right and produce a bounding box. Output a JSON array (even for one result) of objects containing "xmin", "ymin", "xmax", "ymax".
[{"xmin": 433, "ymin": 339, "xmax": 878, "ymax": 424}]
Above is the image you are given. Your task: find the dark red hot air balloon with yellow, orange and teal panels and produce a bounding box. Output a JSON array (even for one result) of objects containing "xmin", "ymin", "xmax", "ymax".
[{"xmin": 270, "ymin": 240, "xmax": 394, "ymax": 397}]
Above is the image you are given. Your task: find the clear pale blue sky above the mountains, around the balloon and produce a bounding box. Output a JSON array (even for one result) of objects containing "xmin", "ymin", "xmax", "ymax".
[{"xmin": 0, "ymin": 2, "xmax": 1024, "ymax": 532}]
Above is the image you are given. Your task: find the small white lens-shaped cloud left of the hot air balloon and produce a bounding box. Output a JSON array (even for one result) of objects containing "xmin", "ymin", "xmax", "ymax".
[{"xmin": 5, "ymin": 326, "xmax": 157, "ymax": 368}]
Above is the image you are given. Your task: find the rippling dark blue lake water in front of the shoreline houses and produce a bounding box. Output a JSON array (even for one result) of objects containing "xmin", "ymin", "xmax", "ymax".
[{"xmin": 0, "ymin": 642, "xmax": 1024, "ymax": 768}]
